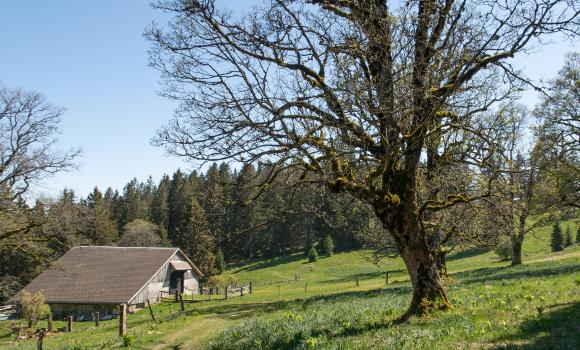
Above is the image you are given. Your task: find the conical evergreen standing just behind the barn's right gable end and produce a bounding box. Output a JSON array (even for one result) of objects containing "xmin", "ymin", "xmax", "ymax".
[{"xmin": 176, "ymin": 199, "xmax": 216, "ymax": 278}]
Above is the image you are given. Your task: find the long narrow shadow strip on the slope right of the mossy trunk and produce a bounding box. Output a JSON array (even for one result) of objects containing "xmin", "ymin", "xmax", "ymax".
[{"xmin": 453, "ymin": 264, "xmax": 580, "ymax": 284}]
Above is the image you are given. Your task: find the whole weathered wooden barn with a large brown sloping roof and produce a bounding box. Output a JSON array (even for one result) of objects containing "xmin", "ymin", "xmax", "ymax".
[{"xmin": 9, "ymin": 246, "xmax": 203, "ymax": 321}]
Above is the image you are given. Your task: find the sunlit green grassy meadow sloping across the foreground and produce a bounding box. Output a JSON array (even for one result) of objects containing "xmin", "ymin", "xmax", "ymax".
[{"xmin": 0, "ymin": 221, "xmax": 580, "ymax": 350}]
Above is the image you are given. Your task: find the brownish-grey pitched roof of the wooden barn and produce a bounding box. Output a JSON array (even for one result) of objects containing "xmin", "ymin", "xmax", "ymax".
[{"xmin": 9, "ymin": 246, "xmax": 203, "ymax": 304}]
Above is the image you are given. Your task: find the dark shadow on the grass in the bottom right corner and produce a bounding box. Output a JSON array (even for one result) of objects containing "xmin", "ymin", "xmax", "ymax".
[{"xmin": 495, "ymin": 302, "xmax": 580, "ymax": 350}]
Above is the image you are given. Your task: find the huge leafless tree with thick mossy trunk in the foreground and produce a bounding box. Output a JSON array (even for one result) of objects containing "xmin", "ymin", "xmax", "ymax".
[{"xmin": 146, "ymin": 0, "xmax": 578, "ymax": 318}]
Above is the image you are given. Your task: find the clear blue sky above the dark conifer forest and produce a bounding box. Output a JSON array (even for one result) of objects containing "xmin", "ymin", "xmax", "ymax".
[{"xmin": 0, "ymin": 0, "xmax": 573, "ymax": 200}]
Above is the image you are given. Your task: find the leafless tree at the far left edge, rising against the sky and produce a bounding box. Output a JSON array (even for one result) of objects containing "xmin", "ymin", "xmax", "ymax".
[{"xmin": 0, "ymin": 85, "xmax": 79, "ymax": 244}]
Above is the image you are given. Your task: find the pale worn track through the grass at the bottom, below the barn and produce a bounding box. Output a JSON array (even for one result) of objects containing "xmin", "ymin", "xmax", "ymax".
[{"xmin": 151, "ymin": 315, "xmax": 231, "ymax": 350}]
